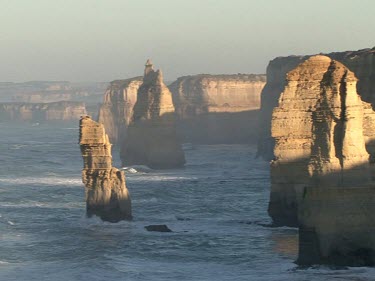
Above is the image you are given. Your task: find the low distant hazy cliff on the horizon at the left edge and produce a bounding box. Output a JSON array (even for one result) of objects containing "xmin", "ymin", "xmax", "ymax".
[{"xmin": 0, "ymin": 101, "xmax": 87, "ymax": 122}]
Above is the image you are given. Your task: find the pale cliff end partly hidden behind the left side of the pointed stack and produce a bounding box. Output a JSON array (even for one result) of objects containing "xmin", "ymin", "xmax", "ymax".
[{"xmin": 98, "ymin": 77, "xmax": 142, "ymax": 143}]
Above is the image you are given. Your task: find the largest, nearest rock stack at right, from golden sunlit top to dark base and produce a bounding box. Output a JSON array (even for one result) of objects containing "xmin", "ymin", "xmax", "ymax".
[{"xmin": 269, "ymin": 55, "xmax": 375, "ymax": 266}]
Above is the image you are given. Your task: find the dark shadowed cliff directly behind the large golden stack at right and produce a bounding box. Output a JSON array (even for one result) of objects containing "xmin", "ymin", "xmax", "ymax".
[{"xmin": 258, "ymin": 48, "xmax": 375, "ymax": 160}]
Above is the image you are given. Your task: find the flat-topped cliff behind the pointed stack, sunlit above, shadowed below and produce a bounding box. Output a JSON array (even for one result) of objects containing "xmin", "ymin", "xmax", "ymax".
[{"xmin": 169, "ymin": 74, "xmax": 265, "ymax": 144}]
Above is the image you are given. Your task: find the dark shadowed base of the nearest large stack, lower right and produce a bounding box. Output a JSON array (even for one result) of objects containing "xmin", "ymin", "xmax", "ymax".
[{"xmin": 297, "ymin": 186, "xmax": 375, "ymax": 266}]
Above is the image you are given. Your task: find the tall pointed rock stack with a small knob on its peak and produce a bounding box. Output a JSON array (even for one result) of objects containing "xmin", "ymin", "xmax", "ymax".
[{"xmin": 120, "ymin": 61, "xmax": 185, "ymax": 169}]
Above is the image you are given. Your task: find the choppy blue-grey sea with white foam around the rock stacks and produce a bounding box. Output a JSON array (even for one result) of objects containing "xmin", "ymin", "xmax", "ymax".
[{"xmin": 0, "ymin": 124, "xmax": 375, "ymax": 281}]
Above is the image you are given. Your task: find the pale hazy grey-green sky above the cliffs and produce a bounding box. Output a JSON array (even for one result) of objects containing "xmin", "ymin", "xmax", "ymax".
[{"xmin": 0, "ymin": 0, "xmax": 375, "ymax": 81}]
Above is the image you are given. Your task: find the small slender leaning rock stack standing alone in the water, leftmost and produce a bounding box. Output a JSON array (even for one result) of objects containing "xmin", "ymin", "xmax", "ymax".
[{"xmin": 79, "ymin": 116, "xmax": 132, "ymax": 222}]
